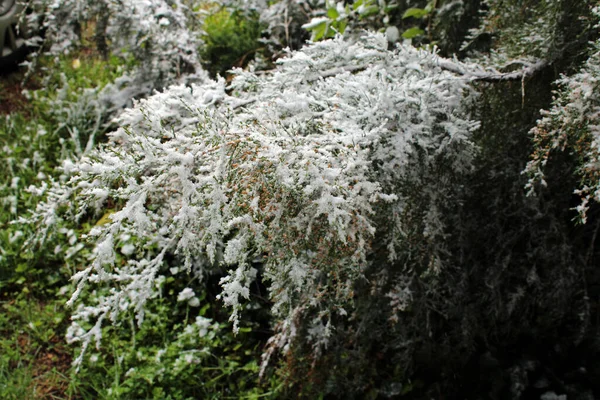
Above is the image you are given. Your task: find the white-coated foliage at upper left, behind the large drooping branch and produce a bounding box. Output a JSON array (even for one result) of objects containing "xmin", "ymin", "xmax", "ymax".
[{"xmin": 25, "ymin": 0, "xmax": 205, "ymax": 110}]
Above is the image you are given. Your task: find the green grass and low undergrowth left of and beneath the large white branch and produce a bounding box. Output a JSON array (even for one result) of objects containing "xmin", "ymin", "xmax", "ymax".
[{"xmin": 0, "ymin": 33, "xmax": 281, "ymax": 399}]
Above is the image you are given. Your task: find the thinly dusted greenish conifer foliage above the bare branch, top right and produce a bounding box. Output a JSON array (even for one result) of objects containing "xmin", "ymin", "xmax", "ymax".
[{"xmin": 462, "ymin": 0, "xmax": 596, "ymax": 71}]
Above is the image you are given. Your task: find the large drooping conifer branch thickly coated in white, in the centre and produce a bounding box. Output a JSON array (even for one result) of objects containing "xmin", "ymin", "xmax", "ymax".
[{"xmin": 23, "ymin": 34, "xmax": 478, "ymax": 368}]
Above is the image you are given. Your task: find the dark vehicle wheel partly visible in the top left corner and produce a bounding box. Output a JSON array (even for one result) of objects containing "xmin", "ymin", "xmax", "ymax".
[{"xmin": 0, "ymin": 0, "xmax": 27, "ymax": 72}]
